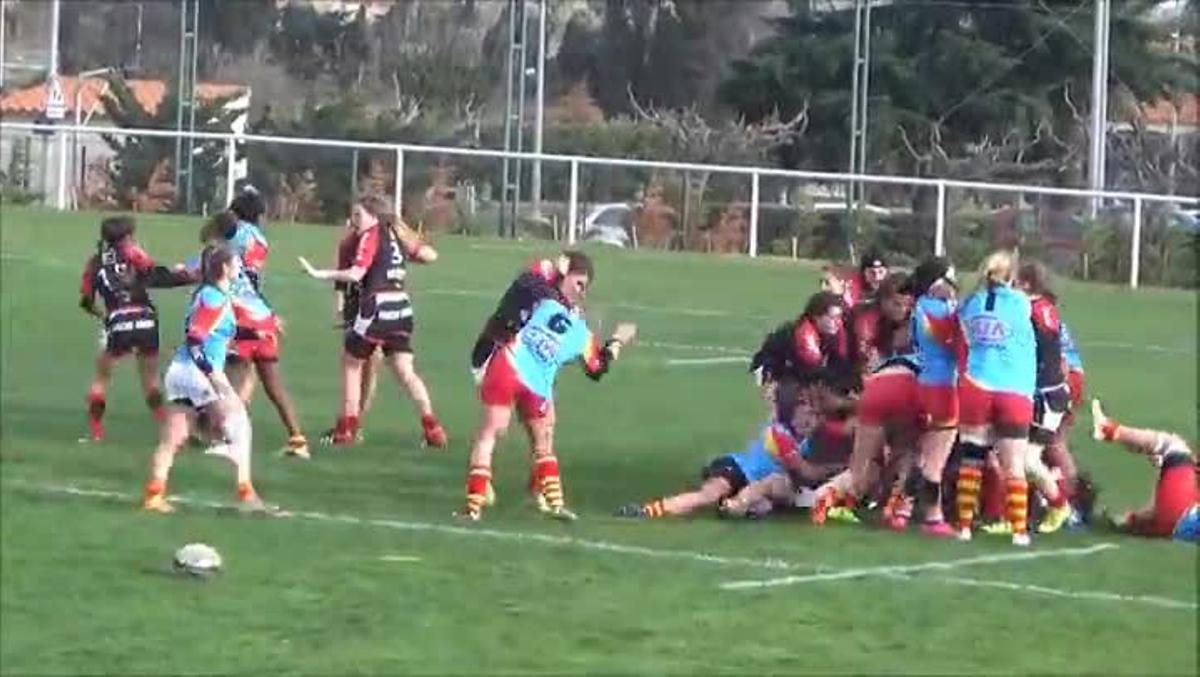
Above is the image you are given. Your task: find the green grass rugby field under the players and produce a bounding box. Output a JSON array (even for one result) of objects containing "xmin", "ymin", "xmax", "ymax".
[{"xmin": 0, "ymin": 208, "xmax": 1198, "ymax": 675}]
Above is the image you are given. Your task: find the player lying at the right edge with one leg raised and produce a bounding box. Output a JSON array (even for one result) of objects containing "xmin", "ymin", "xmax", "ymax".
[{"xmin": 1092, "ymin": 400, "xmax": 1200, "ymax": 543}]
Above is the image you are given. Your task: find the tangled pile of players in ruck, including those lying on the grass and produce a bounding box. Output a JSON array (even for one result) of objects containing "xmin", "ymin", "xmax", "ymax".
[{"xmin": 618, "ymin": 251, "xmax": 1200, "ymax": 546}]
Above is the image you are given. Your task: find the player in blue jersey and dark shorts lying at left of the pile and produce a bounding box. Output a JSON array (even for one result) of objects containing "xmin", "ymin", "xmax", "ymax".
[{"xmin": 617, "ymin": 378, "xmax": 821, "ymax": 519}]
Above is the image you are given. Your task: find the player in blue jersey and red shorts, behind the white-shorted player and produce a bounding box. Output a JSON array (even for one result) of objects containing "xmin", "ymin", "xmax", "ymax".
[{"xmin": 204, "ymin": 208, "xmax": 310, "ymax": 459}]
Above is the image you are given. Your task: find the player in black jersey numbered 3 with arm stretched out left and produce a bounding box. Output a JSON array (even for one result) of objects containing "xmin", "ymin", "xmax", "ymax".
[{"xmin": 300, "ymin": 197, "xmax": 446, "ymax": 448}]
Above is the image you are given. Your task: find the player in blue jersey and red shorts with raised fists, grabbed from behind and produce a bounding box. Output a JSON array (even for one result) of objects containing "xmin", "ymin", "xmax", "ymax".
[{"xmin": 458, "ymin": 252, "xmax": 637, "ymax": 520}]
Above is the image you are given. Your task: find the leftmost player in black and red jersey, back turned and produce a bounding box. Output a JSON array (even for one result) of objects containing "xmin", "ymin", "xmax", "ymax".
[{"xmin": 79, "ymin": 216, "xmax": 187, "ymax": 442}]
